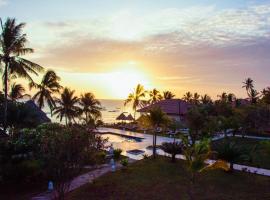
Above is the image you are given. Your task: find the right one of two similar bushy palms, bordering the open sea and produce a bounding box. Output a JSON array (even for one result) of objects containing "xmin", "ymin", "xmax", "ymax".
[{"xmin": 80, "ymin": 92, "xmax": 101, "ymax": 123}]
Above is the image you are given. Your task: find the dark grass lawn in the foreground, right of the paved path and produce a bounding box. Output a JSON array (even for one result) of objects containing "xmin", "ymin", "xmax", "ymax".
[{"xmin": 67, "ymin": 157, "xmax": 270, "ymax": 200}]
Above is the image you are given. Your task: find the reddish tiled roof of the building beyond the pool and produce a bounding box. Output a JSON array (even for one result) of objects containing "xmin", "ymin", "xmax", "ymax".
[{"xmin": 137, "ymin": 99, "xmax": 190, "ymax": 115}]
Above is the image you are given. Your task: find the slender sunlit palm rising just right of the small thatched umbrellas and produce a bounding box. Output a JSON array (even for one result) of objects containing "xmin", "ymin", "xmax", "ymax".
[{"xmin": 124, "ymin": 84, "xmax": 145, "ymax": 119}]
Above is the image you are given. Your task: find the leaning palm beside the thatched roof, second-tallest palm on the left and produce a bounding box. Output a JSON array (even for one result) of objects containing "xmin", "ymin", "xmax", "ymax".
[{"xmin": 29, "ymin": 70, "xmax": 62, "ymax": 113}]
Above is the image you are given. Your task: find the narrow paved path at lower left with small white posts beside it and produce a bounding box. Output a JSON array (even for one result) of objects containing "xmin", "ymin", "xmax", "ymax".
[{"xmin": 31, "ymin": 159, "xmax": 135, "ymax": 200}]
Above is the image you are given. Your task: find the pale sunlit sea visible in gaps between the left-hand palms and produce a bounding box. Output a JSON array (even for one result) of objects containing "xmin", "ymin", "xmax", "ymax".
[{"xmin": 43, "ymin": 99, "xmax": 134, "ymax": 123}]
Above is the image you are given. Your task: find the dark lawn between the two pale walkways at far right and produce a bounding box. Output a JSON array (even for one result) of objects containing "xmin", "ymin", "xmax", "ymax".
[{"xmin": 213, "ymin": 137, "xmax": 270, "ymax": 169}]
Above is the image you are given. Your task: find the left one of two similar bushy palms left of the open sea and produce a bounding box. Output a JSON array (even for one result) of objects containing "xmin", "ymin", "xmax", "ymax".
[{"xmin": 54, "ymin": 88, "xmax": 80, "ymax": 125}]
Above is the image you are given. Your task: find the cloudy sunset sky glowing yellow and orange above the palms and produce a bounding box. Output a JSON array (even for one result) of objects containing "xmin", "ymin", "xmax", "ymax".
[{"xmin": 0, "ymin": 0, "xmax": 270, "ymax": 99}]
